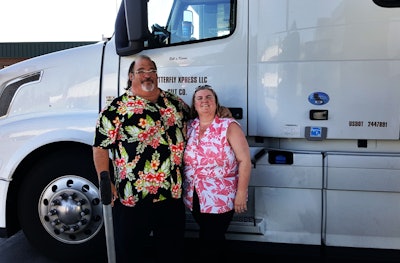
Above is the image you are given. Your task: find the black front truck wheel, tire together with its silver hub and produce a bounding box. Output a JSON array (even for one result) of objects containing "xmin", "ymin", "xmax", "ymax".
[{"xmin": 18, "ymin": 149, "xmax": 107, "ymax": 262}]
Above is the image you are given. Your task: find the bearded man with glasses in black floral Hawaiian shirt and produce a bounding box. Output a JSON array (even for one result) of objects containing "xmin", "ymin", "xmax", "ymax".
[{"xmin": 93, "ymin": 55, "xmax": 189, "ymax": 262}]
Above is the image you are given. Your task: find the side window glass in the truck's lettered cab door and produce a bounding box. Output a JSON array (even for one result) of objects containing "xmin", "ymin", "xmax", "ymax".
[{"xmin": 148, "ymin": 0, "xmax": 236, "ymax": 48}]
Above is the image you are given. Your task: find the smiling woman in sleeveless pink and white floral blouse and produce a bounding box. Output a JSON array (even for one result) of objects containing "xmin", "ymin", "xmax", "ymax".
[{"xmin": 184, "ymin": 85, "xmax": 251, "ymax": 258}]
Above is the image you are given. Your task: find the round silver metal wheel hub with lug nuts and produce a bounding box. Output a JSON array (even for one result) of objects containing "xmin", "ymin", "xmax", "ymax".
[{"xmin": 39, "ymin": 176, "xmax": 103, "ymax": 244}]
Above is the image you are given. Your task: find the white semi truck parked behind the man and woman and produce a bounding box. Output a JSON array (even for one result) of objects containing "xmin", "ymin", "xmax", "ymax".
[{"xmin": 0, "ymin": 0, "xmax": 400, "ymax": 260}]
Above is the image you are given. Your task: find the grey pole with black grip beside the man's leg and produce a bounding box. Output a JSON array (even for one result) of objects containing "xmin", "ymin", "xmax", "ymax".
[{"xmin": 100, "ymin": 171, "xmax": 116, "ymax": 263}]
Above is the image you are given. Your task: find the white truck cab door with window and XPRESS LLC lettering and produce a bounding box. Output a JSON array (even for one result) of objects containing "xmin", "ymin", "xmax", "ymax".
[{"xmin": 121, "ymin": 0, "xmax": 248, "ymax": 132}]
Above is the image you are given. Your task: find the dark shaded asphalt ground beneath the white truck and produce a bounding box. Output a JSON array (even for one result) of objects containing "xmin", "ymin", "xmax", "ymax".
[{"xmin": 0, "ymin": 231, "xmax": 400, "ymax": 263}]
